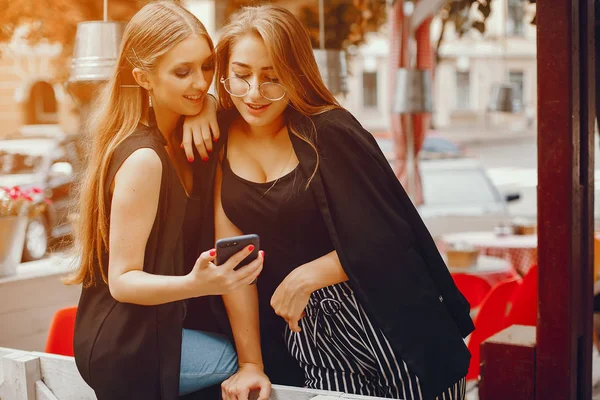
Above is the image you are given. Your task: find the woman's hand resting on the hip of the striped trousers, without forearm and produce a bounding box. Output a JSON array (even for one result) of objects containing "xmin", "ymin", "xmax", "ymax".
[{"xmin": 271, "ymin": 268, "xmax": 312, "ymax": 332}]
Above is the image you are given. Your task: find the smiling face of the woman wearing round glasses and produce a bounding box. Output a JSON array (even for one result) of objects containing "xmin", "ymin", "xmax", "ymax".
[{"xmin": 227, "ymin": 34, "xmax": 289, "ymax": 127}]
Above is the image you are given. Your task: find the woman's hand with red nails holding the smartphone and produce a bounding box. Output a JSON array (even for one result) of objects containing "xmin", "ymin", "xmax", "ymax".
[{"xmin": 187, "ymin": 245, "xmax": 264, "ymax": 297}]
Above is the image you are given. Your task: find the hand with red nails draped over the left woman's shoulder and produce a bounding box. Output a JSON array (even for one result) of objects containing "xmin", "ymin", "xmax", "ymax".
[{"xmin": 181, "ymin": 94, "xmax": 219, "ymax": 161}]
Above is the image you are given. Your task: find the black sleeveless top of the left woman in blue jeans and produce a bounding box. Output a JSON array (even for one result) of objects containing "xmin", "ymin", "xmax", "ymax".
[{"xmin": 74, "ymin": 126, "xmax": 199, "ymax": 400}]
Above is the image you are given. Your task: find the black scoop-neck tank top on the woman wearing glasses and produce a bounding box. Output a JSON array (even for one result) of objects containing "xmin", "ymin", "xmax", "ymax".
[{"xmin": 221, "ymin": 137, "xmax": 334, "ymax": 386}]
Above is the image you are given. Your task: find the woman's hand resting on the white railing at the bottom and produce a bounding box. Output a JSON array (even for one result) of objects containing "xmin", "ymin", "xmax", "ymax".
[{"xmin": 221, "ymin": 364, "xmax": 271, "ymax": 400}]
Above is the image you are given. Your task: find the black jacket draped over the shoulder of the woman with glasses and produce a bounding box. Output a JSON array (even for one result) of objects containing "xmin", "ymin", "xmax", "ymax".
[{"xmin": 190, "ymin": 109, "xmax": 474, "ymax": 398}]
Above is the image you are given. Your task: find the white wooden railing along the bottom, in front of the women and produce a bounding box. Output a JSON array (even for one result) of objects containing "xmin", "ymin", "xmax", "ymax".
[{"xmin": 0, "ymin": 347, "xmax": 383, "ymax": 400}]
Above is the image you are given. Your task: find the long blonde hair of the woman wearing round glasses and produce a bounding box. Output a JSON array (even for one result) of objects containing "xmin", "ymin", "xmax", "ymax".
[{"xmin": 216, "ymin": 4, "xmax": 340, "ymax": 182}]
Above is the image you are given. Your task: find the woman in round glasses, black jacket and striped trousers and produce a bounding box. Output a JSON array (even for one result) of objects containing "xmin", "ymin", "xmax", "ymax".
[{"xmin": 184, "ymin": 5, "xmax": 473, "ymax": 400}]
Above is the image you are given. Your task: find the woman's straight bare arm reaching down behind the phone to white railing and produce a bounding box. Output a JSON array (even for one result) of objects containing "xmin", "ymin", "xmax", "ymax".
[{"xmin": 214, "ymin": 161, "xmax": 271, "ymax": 400}]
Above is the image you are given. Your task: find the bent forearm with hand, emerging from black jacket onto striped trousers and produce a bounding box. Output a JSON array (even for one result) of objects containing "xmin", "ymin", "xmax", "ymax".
[{"xmin": 271, "ymin": 251, "xmax": 348, "ymax": 332}]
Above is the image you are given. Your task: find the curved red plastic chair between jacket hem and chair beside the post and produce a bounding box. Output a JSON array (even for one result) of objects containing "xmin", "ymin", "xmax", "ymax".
[{"xmin": 467, "ymin": 278, "xmax": 521, "ymax": 380}]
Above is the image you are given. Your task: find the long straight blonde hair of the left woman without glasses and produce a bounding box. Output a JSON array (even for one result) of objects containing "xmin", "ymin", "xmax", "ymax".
[{"xmin": 65, "ymin": 1, "xmax": 213, "ymax": 287}]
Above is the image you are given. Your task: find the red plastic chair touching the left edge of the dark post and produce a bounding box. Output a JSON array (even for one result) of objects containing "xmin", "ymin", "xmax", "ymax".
[{"xmin": 507, "ymin": 265, "xmax": 538, "ymax": 326}]
